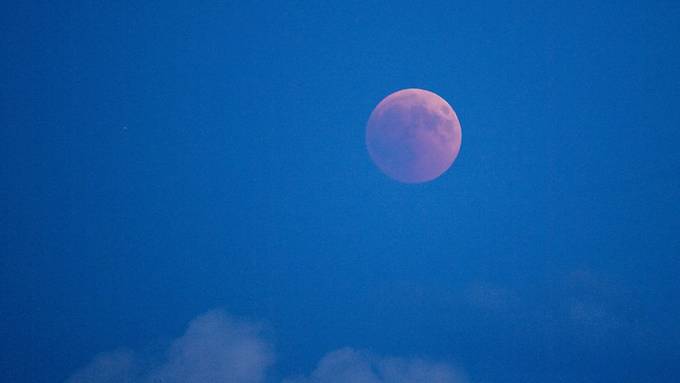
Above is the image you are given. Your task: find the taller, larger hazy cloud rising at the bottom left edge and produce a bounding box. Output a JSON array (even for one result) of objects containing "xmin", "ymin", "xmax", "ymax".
[{"xmin": 67, "ymin": 311, "xmax": 273, "ymax": 383}]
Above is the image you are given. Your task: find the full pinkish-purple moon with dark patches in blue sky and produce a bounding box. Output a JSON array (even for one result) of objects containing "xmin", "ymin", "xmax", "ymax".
[{"xmin": 366, "ymin": 88, "xmax": 462, "ymax": 183}]
